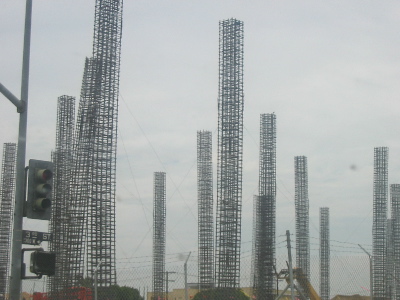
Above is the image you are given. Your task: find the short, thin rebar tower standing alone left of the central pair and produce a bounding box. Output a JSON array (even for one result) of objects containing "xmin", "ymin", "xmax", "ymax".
[{"xmin": 153, "ymin": 172, "xmax": 166, "ymax": 300}]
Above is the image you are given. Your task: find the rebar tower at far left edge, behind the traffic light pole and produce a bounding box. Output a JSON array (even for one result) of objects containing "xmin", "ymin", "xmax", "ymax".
[{"xmin": 0, "ymin": 143, "xmax": 17, "ymax": 300}]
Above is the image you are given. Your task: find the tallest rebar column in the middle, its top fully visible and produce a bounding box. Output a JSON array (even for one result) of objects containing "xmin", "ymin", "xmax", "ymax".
[{"xmin": 215, "ymin": 19, "xmax": 244, "ymax": 288}]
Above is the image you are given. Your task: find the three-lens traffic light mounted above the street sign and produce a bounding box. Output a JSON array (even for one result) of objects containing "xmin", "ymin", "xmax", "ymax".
[{"xmin": 25, "ymin": 159, "xmax": 53, "ymax": 220}]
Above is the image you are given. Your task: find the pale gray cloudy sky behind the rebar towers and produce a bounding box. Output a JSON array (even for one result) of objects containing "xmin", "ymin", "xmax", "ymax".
[{"xmin": 0, "ymin": 0, "xmax": 400, "ymax": 290}]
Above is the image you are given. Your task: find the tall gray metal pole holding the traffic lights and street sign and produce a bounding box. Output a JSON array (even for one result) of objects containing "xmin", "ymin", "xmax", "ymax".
[{"xmin": 10, "ymin": 0, "xmax": 32, "ymax": 300}]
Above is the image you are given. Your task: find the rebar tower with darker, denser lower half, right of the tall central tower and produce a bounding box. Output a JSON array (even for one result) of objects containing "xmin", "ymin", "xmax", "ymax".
[{"xmin": 253, "ymin": 114, "xmax": 276, "ymax": 300}]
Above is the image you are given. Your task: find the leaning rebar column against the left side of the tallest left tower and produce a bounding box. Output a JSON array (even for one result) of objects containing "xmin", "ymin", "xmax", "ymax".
[{"xmin": 64, "ymin": 58, "xmax": 95, "ymax": 290}]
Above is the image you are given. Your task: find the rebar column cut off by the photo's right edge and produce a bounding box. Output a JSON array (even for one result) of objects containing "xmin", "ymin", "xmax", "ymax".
[{"xmin": 390, "ymin": 184, "xmax": 400, "ymax": 300}]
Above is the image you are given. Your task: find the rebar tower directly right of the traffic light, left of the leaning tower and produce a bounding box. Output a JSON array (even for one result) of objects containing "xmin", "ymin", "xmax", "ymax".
[{"xmin": 48, "ymin": 95, "xmax": 75, "ymax": 299}]
